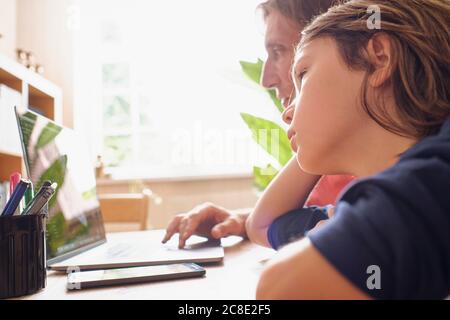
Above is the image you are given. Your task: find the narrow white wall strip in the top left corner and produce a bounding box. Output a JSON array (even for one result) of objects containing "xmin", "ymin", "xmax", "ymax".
[{"xmin": 0, "ymin": 0, "xmax": 17, "ymax": 59}]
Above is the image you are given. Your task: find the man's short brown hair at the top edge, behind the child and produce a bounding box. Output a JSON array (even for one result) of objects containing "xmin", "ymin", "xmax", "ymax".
[{"xmin": 258, "ymin": 0, "xmax": 336, "ymax": 26}]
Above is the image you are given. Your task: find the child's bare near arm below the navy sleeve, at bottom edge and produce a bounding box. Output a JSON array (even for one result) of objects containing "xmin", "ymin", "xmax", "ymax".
[{"xmin": 256, "ymin": 238, "xmax": 370, "ymax": 300}]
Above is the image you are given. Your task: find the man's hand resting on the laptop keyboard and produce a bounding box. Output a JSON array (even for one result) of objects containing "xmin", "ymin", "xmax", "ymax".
[{"xmin": 162, "ymin": 203, "xmax": 250, "ymax": 248}]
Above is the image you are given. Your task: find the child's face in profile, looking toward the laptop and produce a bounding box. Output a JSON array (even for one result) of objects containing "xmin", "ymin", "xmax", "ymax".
[{"xmin": 288, "ymin": 38, "xmax": 373, "ymax": 174}]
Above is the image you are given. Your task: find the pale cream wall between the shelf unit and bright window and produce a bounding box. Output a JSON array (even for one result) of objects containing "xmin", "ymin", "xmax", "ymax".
[{"xmin": 16, "ymin": 0, "xmax": 74, "ymax": 127}]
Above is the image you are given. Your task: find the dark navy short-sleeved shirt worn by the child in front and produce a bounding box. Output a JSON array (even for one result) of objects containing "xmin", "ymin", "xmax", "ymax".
[{"xmin": 268, "ymin": 119, "xmax": 450, "ymax": 299}]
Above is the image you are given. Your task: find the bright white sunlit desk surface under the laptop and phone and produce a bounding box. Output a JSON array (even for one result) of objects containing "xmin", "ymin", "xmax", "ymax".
[{"xmin": 19, "ymin": 230, "xmax": 274, "ymax": 300}]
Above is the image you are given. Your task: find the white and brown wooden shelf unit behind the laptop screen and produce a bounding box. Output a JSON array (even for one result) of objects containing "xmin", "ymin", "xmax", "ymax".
[{"xmin": 0, "ymin": 54, "xmax": 62, "ymax": 182}]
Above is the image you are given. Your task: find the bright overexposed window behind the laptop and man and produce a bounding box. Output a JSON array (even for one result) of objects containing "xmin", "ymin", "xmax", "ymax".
[{"xmin": 75, "ymin": 0, "xmax": 280, "ymax": 177}]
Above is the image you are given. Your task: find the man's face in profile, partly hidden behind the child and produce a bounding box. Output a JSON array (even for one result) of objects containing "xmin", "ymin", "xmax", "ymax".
[{"xmin": 261, "ymin": 10, "xmax": 301, "ymax": 108}]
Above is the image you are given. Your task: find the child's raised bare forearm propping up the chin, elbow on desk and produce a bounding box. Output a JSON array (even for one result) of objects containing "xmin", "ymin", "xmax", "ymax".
[{"xmin": 246, "ymin": 157, "xmax": 320, "ymax": 247}]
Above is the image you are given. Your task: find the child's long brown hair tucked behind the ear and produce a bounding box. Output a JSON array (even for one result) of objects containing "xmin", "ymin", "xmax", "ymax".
[{"xmin": 298, "ymin": 0, "xmax": 450, "ymax": 139}]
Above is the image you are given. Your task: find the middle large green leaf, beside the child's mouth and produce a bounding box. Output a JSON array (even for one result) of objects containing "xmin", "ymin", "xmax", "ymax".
[{"xmin": 241, "ymin": 113, "xmax": 293, "ymax": 166}]
